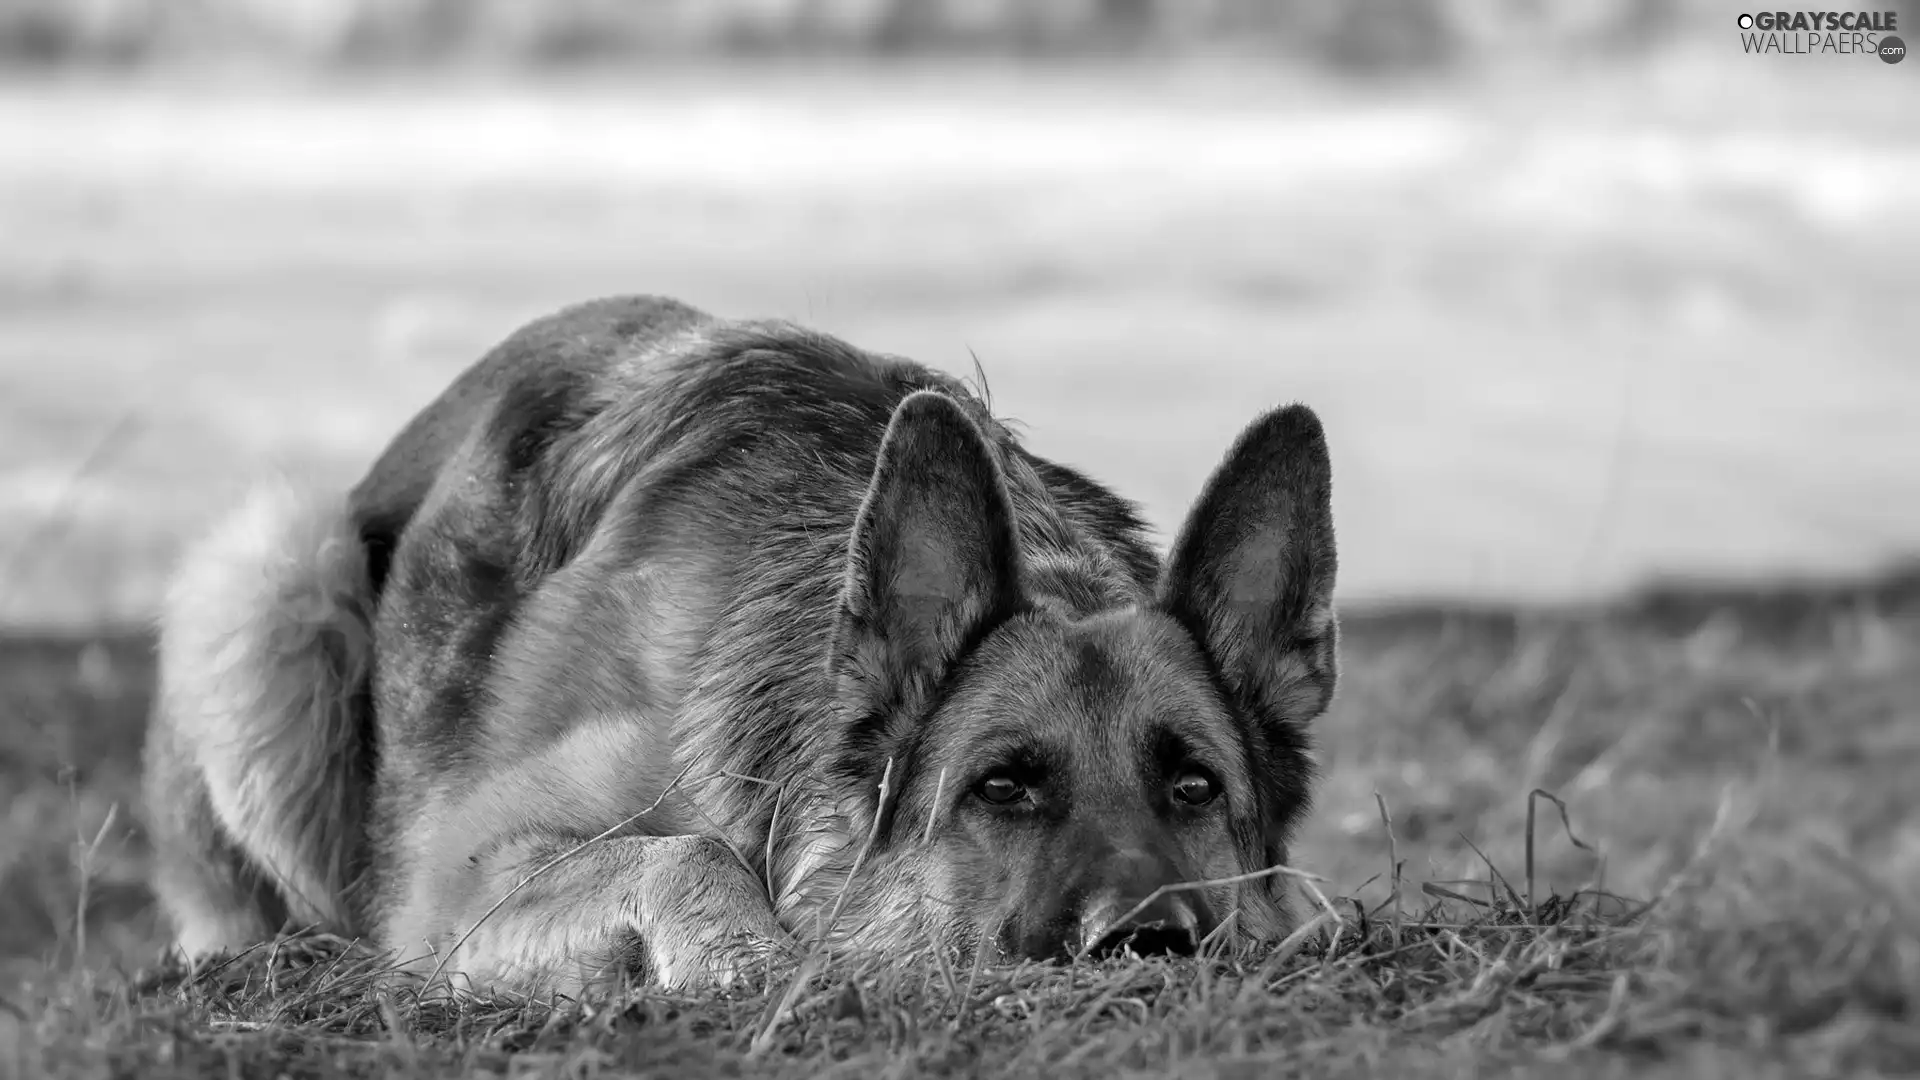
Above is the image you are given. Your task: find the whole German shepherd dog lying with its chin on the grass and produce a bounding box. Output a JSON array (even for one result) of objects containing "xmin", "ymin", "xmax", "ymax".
[{"xmin": 146, "ymin": 298, "xmax": 1336, "ymax": 995}]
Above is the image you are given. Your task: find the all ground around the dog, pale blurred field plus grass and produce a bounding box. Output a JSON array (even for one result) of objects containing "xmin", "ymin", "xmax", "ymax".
[{"xmin": 0, "ymin": 56, "xmax": 1920, "ymax": 1078}]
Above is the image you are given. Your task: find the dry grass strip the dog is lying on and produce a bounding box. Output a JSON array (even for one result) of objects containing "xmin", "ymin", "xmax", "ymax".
[{"xmin": 0, "ymin": 575, "xmax": 1920, "ymax": 1078}]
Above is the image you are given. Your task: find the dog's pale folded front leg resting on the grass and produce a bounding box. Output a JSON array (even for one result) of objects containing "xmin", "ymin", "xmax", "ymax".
[{"xmin": 392, "ymin": 836, "xmax": 783, "ymax": 995}]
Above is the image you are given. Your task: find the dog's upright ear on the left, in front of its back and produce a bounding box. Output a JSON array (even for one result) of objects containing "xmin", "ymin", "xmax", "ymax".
[{"xmin": 829, "ymin": 390, "xmax": 1021, "ymax": 773}]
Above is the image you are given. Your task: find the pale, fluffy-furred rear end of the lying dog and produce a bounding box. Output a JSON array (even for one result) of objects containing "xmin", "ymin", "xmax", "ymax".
[{"xmin": 144, "ymin": 484, "xmax": 374, "ymax": 957}]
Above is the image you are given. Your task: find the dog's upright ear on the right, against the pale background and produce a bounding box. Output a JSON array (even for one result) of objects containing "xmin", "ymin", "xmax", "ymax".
[{"xmin": 1160, "ymin": 405, "xmax": 1338, "ymax": 724}]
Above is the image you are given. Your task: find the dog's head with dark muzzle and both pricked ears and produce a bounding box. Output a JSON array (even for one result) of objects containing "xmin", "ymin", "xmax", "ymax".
[{"xmin": 831, "ymin": 392, "xmax": 1338, "ymax": 957}]
